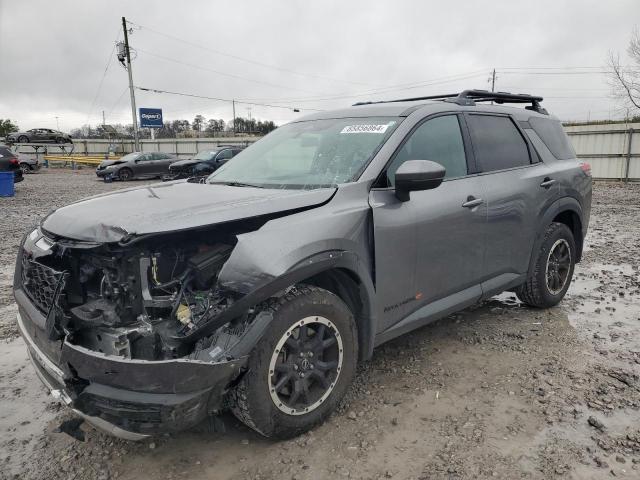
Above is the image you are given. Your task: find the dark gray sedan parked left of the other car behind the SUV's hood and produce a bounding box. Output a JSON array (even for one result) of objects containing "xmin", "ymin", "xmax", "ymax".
[{"xmin": 96, "ymin": 152, "xmax": 178, "ymax": 182}]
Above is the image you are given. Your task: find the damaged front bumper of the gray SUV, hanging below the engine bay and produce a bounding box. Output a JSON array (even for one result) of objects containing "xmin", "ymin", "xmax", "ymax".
[{"xmin": 15, "ymin": 289, "xmax": 246, "ymax": 440}]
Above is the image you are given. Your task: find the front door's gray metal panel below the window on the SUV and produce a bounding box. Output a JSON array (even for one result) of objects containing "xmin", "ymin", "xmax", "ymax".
[{"xmin": 370, "ymin": 177, "xmax": 487, "ymax": 329}]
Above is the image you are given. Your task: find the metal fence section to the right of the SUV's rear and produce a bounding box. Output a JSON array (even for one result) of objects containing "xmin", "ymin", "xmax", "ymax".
[{"xmin": 565, "ymin": 123, "xmax": 640, "ymax": 181}]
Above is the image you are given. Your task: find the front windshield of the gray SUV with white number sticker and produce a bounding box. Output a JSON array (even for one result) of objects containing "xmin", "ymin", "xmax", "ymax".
[{"xmin": 207, "ymin": 117, "xmax": 400, "ymax": 189}]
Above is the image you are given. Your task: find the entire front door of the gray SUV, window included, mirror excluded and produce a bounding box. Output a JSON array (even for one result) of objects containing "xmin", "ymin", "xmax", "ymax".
[{"xmin": 370, "ymin": 113, "xmax": 487, "ymax": 329}]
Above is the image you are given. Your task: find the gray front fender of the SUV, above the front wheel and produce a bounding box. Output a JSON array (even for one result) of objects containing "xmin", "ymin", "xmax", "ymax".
[{"xmin": 176, "ymin": 185, "xmax": 376, "ymax": 352}]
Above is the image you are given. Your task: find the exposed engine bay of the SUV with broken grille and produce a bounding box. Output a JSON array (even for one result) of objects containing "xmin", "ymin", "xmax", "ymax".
[{"xmin": 21, "ymin": 222, "xmax": 264, "ymax": 361}]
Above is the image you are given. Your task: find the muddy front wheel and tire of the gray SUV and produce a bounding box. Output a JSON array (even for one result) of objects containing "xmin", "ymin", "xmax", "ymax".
[{"xmin": 231, "ymin": 286, "xmax": 358, "ymax": 438}]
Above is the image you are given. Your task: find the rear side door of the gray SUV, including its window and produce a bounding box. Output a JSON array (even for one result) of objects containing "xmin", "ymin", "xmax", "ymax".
[{"xmin": 467, "ymin": 114, "xmax": 558, "ymax": 284}]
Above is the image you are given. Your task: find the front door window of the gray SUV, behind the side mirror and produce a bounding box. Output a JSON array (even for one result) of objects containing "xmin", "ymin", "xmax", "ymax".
[{"xmin": 387, "ymin": 115, "xmax": 467, "ymax": 186}]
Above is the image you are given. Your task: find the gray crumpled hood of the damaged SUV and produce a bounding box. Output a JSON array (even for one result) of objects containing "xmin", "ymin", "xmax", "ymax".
[{"xmin": 42, "ymin": 181, "xmax": 336, "ymax": 242}]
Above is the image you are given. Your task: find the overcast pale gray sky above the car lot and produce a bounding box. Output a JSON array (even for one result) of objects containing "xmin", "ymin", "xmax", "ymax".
[{"xmin": 0, "ymin": 0, "xmax": 640, "ymax": 131}]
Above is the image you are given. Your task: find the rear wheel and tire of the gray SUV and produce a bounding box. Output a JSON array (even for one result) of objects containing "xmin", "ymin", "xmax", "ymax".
[{"xmin": 515, "ymin": 222, "xmax": 576, "ymax": 308}]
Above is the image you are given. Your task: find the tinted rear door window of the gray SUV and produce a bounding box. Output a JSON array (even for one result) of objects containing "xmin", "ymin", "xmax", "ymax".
[{"xmin": 467, "ymin": 114, "xmax": 531, "ymax": 172}]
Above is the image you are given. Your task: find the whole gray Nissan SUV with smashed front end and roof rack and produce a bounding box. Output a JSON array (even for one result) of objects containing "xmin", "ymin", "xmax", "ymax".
[{"xmin": 14, "ymin": 90, "xmax": 591, "ymax": 439}]
